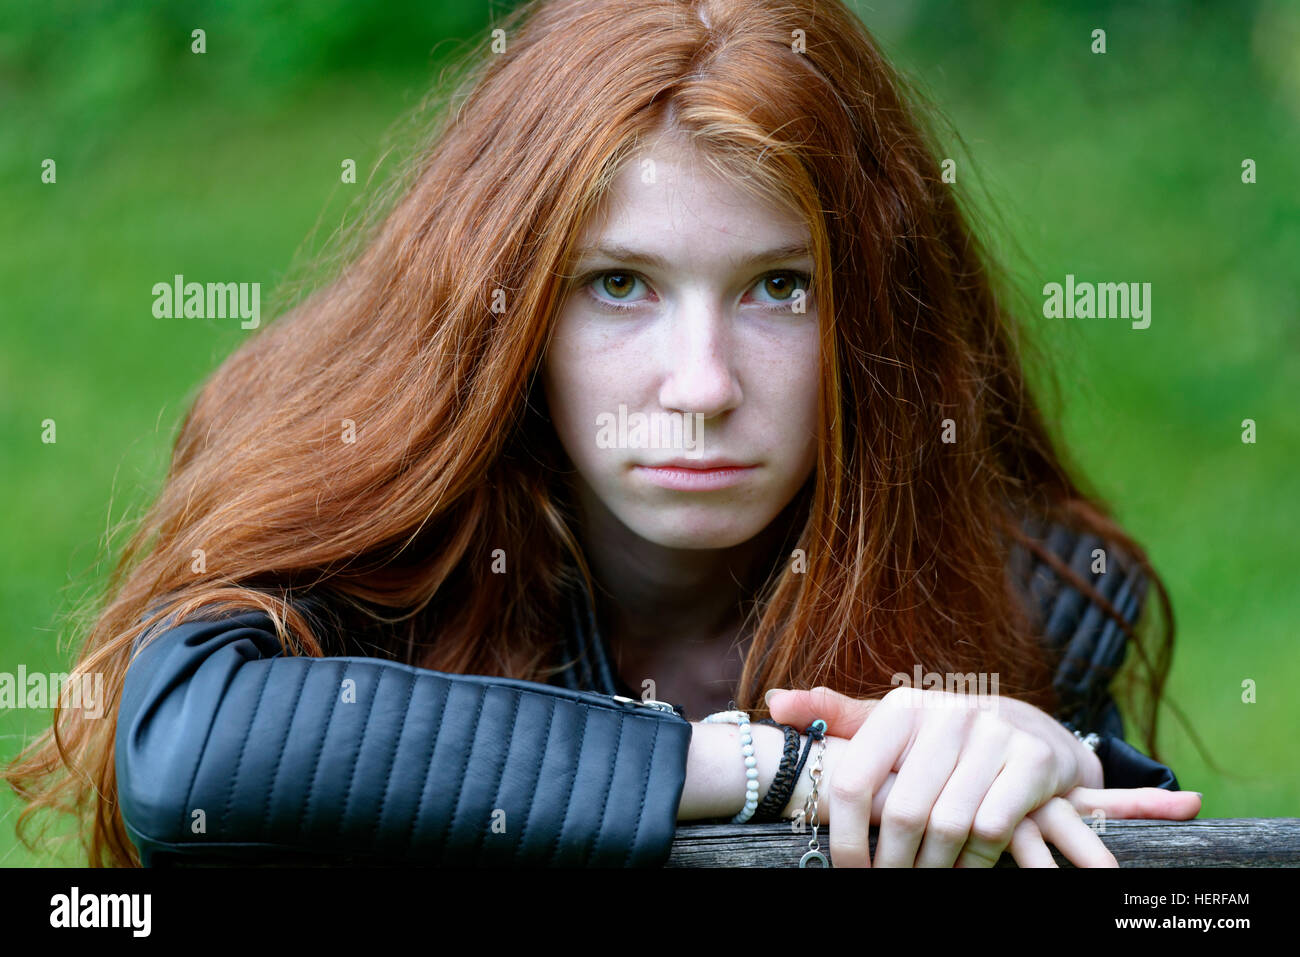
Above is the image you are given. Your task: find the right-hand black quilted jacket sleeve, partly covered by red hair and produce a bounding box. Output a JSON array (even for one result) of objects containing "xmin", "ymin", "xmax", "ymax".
[{"xmin": 1021, "ymin": 524, "xmax": 1179, "ymax": 791}]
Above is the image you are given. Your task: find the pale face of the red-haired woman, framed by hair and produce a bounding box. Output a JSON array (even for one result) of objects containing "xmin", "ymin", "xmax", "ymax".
[{"xmin": 543, "ymin": 139, "xmax": 819, "ymax": 549}]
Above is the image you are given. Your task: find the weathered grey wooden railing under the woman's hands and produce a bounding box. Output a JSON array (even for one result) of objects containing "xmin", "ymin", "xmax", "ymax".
[{"xmin": 668, "ymin": 818, "xmax": 1300, "ymax": 867}]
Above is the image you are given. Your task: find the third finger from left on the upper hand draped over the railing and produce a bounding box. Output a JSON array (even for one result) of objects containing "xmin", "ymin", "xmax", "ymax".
[{"xmin": 909, "ymin": 718, "xmax": 1015, "ymax": 867}]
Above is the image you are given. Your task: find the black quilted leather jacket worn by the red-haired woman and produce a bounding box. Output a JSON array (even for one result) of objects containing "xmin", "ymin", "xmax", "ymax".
[{"xmin": 116, "ymin": 529, "xmax": 1178, "ymax": 866}]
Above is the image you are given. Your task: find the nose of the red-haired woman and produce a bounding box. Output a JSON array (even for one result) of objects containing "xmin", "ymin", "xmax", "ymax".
[{"xmin": 659, "ymin": 304, "xmax": 742, "ymax": 419}]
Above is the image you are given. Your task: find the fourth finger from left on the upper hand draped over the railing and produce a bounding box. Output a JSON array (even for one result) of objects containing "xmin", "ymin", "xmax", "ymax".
[{"xmin": 958, "ymin": 731, "xmax": 1053, "ymax": 867}]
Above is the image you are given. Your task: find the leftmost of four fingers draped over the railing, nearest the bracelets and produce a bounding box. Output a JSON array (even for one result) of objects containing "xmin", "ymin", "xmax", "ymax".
[{"xmin": 827, "ymin": 707, "xmax": 917, "ymax": 867}]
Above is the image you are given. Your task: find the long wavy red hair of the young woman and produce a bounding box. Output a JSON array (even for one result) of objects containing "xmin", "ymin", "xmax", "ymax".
[{"xmin": 5, "ymin": 0, "xmax": 1173, "ymax": 866}]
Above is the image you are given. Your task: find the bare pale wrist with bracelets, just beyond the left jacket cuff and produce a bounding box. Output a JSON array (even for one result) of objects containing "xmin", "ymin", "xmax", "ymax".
[{"xmin": 677, "ymin": 722, "xmax": 803, "ymax": 820}]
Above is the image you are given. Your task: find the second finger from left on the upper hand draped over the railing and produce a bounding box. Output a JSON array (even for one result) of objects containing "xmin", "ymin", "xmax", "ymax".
[{"xmin": 873, "ymin": 709, "xmax": 972, "ymax": 867}]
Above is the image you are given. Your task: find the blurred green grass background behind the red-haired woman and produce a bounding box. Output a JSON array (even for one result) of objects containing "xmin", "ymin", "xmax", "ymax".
[{"xmin": 0, "ymin": 0, "xmax": 1300, "ymax": 866}]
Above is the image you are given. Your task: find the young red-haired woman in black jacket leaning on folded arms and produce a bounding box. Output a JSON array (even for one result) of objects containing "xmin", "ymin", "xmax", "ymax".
[{"xmin": 8, "ymin": 0, "xmax": 1200, "ymax": 866}]
